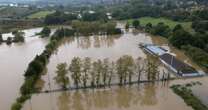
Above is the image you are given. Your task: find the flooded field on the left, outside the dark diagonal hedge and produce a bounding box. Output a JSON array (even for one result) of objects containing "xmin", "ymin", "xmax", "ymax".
[{"xmin": 0, "ymin": 28, "xmax": 48, "ymax": 110}]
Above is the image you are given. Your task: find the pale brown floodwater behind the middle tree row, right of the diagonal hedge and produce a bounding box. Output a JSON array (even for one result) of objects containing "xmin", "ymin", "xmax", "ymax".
[{"xmin": 42, "ymin": 33, "xmax": 151, "ymax": 90}]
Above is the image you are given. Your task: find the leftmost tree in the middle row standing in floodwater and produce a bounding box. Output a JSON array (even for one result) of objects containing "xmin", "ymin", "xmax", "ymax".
[{"xmin": 54, "ymin": 63, "xmax": 69, "ymax": 89}]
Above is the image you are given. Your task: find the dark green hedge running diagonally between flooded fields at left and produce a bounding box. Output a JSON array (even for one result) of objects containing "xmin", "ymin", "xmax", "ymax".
[{"xmin": 11, "ymin": 28, "xmax": 74, "ymax": 110}]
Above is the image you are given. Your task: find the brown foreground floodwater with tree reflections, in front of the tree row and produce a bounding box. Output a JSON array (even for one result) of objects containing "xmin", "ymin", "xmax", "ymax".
[{"xmin": 23, "ymin": 84, "xmax": 192, "ymax": 110}]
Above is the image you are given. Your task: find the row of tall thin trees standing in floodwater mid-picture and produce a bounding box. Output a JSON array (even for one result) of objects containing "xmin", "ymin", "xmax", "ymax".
[{"xmin": 54, "ymin": 55, "xmax": 170, "ymax": 89}]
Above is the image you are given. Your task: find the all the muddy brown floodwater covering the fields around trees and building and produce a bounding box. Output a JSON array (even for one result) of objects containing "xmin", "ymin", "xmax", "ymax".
[{"xmin": 0, "ymin": 28, "xmax": 207, "ymax": 110}]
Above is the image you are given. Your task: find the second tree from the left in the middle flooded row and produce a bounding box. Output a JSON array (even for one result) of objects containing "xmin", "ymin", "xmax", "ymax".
[{"xmin": 69, "ymin": 57, "xmax": 82, "ymax": 88}]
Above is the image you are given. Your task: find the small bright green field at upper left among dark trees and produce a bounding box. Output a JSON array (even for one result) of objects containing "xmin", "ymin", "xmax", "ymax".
[{"xmin": 28, "ymin": 11, "xmax": 55, "ymax": 19}]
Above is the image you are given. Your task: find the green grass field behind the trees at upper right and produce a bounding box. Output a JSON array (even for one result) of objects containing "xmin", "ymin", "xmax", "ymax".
[{"xmin": 128, "ymin": 17, "xmax": 193, "ymax": 32}]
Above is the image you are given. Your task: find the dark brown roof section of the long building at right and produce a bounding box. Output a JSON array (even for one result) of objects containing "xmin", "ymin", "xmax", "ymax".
[{"xmin": 160, "ymin": 53, "xmax": 198, "ymax": 74}]
